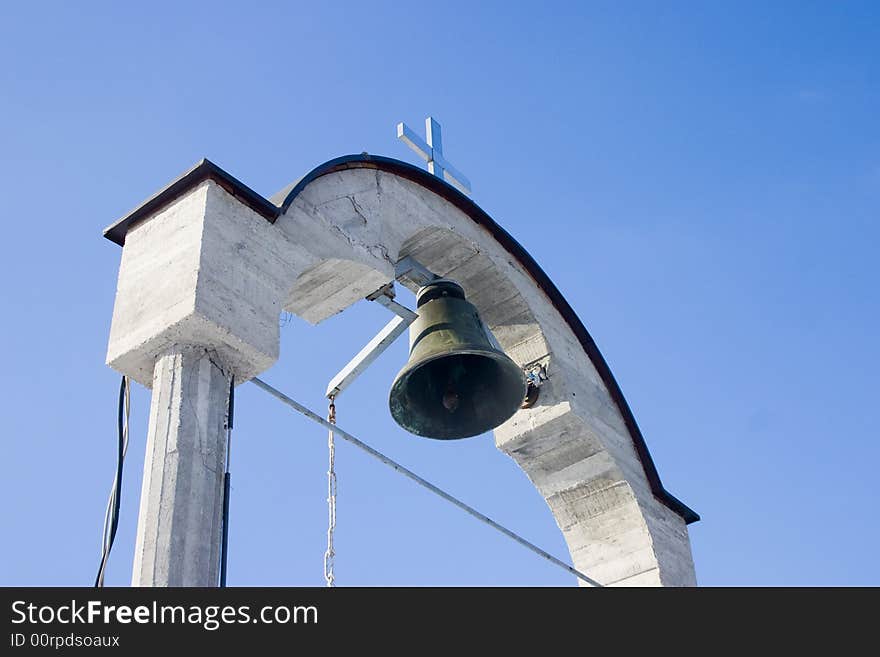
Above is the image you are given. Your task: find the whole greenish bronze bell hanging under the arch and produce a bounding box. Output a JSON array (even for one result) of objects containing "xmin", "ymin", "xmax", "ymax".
[{"xmin": 388, "ymin": 279, "xmax": 526, "ymax": 440}]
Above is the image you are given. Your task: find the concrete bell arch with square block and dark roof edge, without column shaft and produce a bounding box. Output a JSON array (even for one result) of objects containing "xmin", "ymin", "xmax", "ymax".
[{"xmin": 107, "ymin": 156, "xmax": 697, "ymax": 585}]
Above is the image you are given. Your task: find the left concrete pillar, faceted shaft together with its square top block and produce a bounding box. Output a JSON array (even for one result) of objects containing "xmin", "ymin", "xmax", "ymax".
[{"xmin": 107, "ymin": 180, "xmax": 300, "ymax": 586}]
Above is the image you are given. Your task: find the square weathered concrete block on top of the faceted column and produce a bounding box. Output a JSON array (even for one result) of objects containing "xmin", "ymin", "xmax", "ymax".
[{"xmin": 107, "ymin": 180, "xmax": 317, "ymax": 387}]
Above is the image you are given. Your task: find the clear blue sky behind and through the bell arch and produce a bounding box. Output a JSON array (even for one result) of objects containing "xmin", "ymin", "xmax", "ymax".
[{"xmin": 0, "ymin": 1, "xmax": 880, "ymax": 585}]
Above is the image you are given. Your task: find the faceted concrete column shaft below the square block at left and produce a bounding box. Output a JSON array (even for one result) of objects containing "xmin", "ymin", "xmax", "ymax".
[{"xmin": 131, "ymin": 346, "xmax": 230, "ymax": 586}]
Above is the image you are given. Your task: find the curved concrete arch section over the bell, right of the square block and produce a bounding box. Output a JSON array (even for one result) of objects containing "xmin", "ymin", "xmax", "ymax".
[{"xmin": 272, "ymin": 162, "xmax": 696, "ymax": 586}]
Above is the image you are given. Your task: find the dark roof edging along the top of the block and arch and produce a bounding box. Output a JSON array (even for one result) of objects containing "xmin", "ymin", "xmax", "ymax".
[{"xmin": 104, "ymin": 153, "xmax": 700, "ymax": 524}]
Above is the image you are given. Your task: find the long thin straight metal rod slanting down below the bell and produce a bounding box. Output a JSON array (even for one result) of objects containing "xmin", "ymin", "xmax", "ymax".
[{"xmin": 251, "ymin": 377, "xmax": 602, "ymax": 587}]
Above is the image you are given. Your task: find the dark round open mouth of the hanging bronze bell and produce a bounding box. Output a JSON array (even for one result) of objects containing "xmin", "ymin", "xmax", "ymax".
[{"xmin": 388, "ymin": 350, "xmax": 526, "ymax": 440}]
